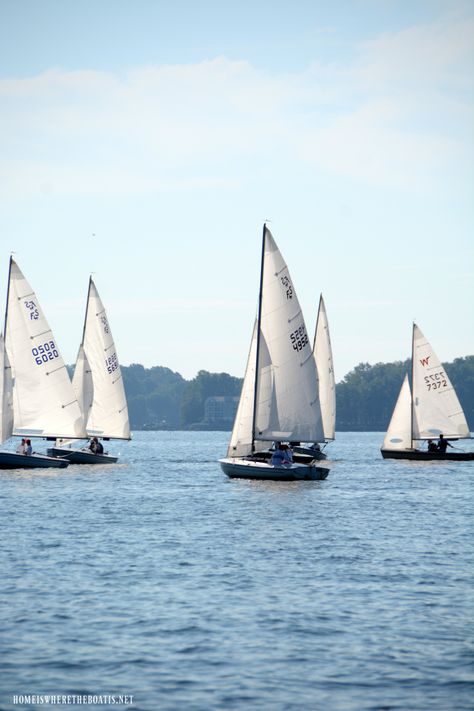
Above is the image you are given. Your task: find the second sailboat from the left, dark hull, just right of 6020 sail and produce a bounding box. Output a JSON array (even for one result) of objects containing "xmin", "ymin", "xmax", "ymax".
[{"xmin": 48, "ymin": 277, "xmax": 131, "ymax": 464}]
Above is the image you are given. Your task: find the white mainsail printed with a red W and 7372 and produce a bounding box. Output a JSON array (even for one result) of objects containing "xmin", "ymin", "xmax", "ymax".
[{"xmin": 412, "ymin": 324, "xmax": 470, "ymax": 439}]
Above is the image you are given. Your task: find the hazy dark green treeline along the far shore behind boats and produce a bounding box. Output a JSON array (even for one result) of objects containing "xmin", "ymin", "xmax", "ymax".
[{"xmin": 122, "ymin": 356, "xmax": 474, "ymax": 432}]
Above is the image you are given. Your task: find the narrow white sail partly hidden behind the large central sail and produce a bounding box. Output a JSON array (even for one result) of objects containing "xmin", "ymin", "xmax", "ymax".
[{"xmin": 313, "ymin": 295, "xmax": 336, "ymax": 441}]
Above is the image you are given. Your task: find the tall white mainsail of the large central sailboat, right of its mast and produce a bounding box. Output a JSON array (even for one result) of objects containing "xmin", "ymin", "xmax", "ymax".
[{"xmin": 254, "ymin": 227, "xmax": 324, "ymax": 442}]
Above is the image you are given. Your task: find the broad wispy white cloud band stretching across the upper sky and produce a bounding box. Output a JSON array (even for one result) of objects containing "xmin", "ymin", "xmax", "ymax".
[{"xmin": 0, "ymin": 13, "xmax": 474, "ymax": 196}]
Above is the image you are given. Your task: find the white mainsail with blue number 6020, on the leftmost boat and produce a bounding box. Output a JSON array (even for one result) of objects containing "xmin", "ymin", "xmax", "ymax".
[{"xmin": 5, "ymin": 259, "xmax": 86, "ymax": 438}]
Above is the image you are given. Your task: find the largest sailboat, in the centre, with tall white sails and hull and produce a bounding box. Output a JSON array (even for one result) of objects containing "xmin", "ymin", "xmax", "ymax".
[{"xmin": 219, "ymin": 225, "xmax": 329, "ymax": 481}]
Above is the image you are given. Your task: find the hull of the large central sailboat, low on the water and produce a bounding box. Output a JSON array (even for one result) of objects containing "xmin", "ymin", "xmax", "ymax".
[{"xmin": 219, "ymin": 459, "xmax": 329, "ymax": 481}]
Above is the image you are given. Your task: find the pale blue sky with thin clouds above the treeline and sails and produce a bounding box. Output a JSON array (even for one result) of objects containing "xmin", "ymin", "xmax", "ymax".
[{"xmin": 0, "ymin": 0, "xmax": 474, "ymax": 381}]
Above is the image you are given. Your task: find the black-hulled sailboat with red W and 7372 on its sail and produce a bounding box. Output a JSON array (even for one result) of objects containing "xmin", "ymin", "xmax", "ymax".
[{"xmin": 381, "ymin": 324, "xmax": 474, "ymax": 461}]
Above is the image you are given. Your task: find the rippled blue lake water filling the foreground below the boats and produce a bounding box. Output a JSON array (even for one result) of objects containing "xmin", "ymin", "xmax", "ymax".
[{"xmin": 0, "ymin": 432, "xmax": 474, "ymax": 711}]
